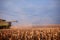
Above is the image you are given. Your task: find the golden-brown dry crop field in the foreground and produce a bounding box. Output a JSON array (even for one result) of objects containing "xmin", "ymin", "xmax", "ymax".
[{"xmin": 0, "ymin": 28, "xmax": 60, "ymax": 40}]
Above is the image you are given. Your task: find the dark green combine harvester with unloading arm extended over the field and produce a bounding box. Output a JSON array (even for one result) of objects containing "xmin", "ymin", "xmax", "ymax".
[{"xmin": 0, "ymin": 19, "xmax": 17, "ymax": 29}]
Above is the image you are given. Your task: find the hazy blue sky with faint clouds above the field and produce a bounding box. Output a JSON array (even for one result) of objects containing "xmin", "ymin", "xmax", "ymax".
[{"xmin": 0, "ymin": 0, "xmax": 60, "ymax": 25}]
